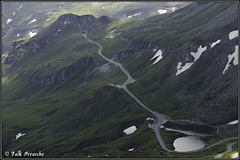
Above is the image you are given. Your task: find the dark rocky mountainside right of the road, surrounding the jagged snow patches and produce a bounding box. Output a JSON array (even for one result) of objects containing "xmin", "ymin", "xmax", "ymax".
[{"xmin": 113, "ymin": 3, "xmax": 238, "ymax": 122}]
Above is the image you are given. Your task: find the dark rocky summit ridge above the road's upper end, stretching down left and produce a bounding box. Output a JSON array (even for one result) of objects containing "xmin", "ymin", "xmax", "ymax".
[{"xmin": 3, "ymin": 14, "xmax": 112, "ymax": 65}]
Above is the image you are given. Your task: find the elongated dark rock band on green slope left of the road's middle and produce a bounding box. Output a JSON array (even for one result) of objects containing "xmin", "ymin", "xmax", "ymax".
[{"xmin": 23, "ymin": 57, "xmax": 96, "ymax": 87}]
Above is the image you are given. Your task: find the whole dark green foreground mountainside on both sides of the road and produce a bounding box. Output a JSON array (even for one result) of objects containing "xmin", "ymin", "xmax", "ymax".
[{"xmin": 2, "ymin": 2, "xmax": 238, "ymax": 158}]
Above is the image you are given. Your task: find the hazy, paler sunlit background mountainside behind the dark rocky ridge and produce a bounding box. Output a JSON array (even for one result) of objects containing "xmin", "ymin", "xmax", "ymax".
[{"xmin": 2, "ymin": 2, "xmax": 188, "ymax": 52}]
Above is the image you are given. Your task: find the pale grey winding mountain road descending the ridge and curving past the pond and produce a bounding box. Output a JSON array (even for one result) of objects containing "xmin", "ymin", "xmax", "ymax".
[{"xmin": 82, "ymin": 33, "xmax": 238, "ymax": 153}]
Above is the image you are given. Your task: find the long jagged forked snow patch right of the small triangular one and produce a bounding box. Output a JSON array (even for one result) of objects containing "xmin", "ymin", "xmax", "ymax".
[{"xmin": 176, "ymin": 45, "xmax": 207, "ymax": 76}]
